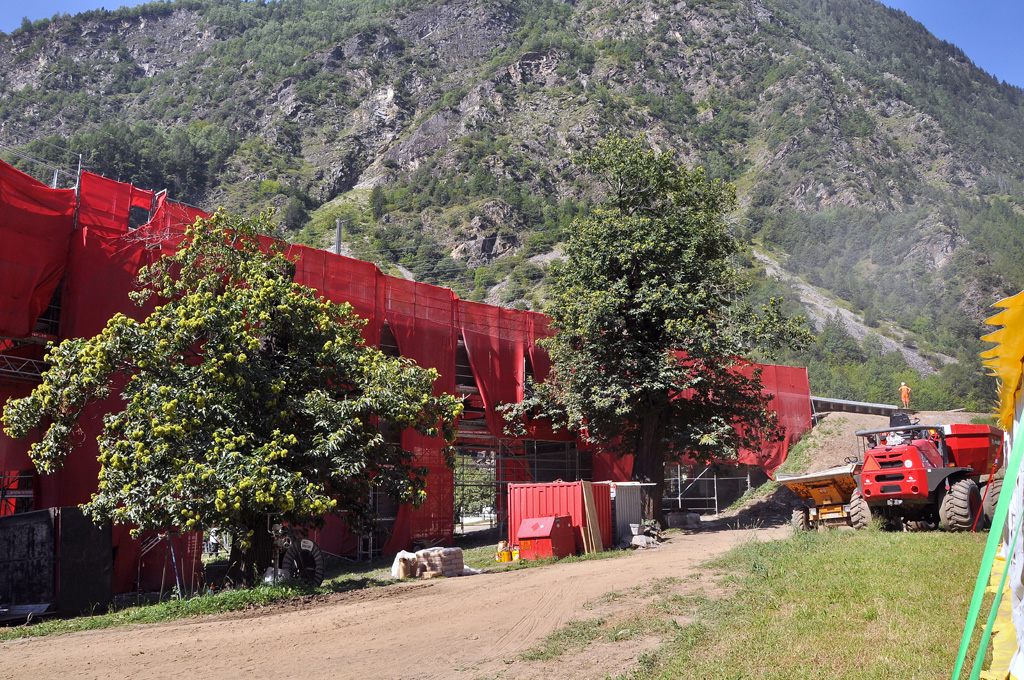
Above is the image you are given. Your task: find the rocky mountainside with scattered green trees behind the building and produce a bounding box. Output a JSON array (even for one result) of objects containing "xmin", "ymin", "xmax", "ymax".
[{"xmin": 0, "ymin": 0, "xmax": 1024, "ymax": 408}]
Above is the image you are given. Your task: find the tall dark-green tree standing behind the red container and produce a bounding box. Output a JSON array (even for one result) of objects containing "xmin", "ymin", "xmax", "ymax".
[{"xmin": 508, "ymin": 137, "xmax": 808, "ymax": 518}]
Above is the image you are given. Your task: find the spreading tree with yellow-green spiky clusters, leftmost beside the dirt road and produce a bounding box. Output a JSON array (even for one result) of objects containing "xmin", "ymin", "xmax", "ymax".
[{"xmin": 3, "ymin": 213, "xmax": 462, "ymax": 584}]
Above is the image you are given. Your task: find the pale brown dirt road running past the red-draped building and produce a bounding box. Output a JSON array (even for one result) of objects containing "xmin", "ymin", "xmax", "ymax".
[{"xmin": 0, "ymin": 526, "xmax": 790, "ymax": 680}]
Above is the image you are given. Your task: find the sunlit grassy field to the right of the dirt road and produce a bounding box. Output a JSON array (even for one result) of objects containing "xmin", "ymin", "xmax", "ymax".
[{"xmin": 520, "ymin": 527, "xmax": 990, "ymax": 680}]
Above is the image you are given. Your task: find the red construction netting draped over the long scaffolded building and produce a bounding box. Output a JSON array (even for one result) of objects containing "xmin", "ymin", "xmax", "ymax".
[{"xmin": 0, "ymin": 157, "xmax": 810, "ymax": 557}]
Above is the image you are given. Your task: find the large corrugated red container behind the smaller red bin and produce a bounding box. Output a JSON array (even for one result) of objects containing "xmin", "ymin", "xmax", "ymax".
[{"xmin": 508, "ymin": 481, "xmax": 612, "ymax": 552}]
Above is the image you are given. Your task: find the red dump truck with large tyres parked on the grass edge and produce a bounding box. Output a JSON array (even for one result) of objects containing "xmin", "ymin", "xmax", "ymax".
[{"xmin": 857, "ymin": 413, "xmax": 1002, "ymax": 532}]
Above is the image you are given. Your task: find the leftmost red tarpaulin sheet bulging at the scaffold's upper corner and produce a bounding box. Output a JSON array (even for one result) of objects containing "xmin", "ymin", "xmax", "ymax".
[{"xmin": 0, "ymin": 161, "xmax": 75, "ymax": 338}]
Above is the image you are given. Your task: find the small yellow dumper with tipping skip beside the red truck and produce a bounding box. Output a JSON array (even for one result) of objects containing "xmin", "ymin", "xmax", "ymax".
[{"xmin": 776, "ymin": 462, "xmax": 871, "ymax": 530}]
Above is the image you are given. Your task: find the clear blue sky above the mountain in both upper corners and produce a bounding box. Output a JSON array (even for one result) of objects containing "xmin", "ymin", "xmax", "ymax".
[{"xmin": 0, "ymin": 0, "xmax": 1024, "ymax": 87}]
